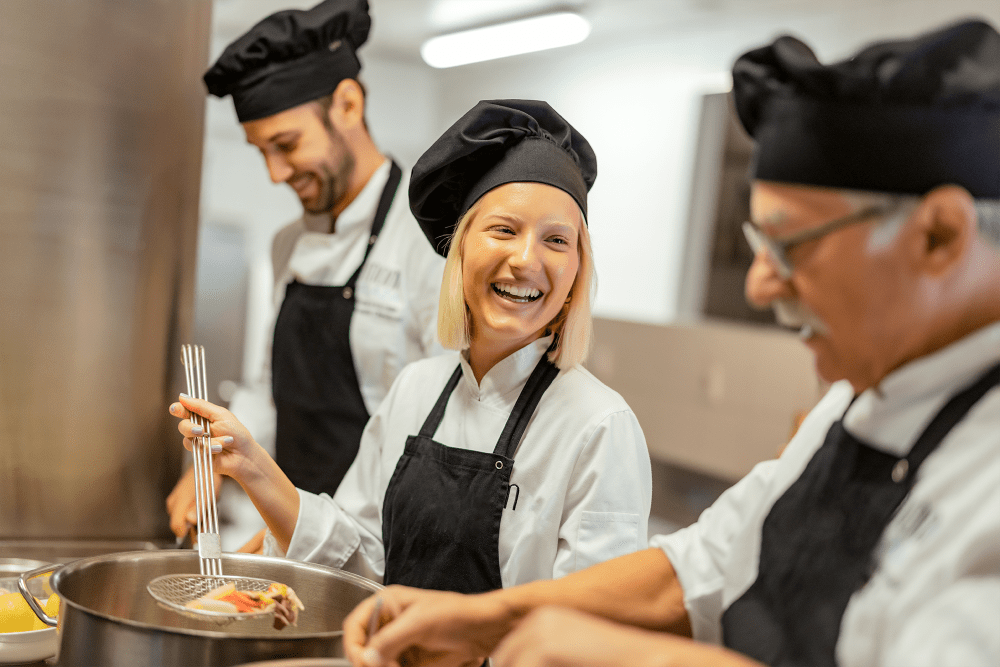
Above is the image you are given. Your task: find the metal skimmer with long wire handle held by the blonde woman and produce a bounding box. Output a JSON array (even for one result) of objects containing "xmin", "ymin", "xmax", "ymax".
[{"xmin": 146, "ymin": 345, "xmax": 273, "ymax": 624}]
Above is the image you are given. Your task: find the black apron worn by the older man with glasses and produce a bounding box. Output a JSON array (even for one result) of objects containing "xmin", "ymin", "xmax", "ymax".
[{"xmin": 722, "ymin": 364, "xmax": 1000, "ymax": 667}]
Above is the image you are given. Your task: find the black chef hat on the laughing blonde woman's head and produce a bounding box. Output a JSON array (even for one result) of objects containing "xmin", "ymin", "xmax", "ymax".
[{"xmin": 410, "ymin": 100, "xmax": 597, "ymax": 255}]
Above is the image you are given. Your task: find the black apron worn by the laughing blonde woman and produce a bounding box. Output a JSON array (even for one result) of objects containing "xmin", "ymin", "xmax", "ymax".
[{"xmin": 382, "ymin": 353, "xmax": 559, "ymax": 593}]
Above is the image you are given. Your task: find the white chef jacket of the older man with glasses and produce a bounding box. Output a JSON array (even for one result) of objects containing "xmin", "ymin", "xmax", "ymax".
[{"xmin": 651, "ymin": 323, "xmax": 1000, "ymax": 667}]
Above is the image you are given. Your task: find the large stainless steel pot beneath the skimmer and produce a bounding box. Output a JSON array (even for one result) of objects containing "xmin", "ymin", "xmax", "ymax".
[{"xmin": 20, "ymin": 550, "xmax": 381, "ymax": 667}]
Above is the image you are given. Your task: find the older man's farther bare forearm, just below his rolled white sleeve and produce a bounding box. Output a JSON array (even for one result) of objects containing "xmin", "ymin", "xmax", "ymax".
[{"xmin": 486, "ymin": 549, "xmax": 691, "ymax": 637}]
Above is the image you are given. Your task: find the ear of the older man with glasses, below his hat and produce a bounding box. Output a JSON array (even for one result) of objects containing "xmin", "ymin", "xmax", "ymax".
[{"xmin": 910, "ymin": 185, "xmax": 978, "ymax": 276}]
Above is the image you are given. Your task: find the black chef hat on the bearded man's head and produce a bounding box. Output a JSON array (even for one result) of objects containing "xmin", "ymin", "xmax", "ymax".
[{"xmin": 204, "ymin": 0, "xmax": 371, "ymax": 123}]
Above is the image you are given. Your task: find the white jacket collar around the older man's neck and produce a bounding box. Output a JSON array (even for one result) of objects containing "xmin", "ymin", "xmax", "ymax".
[{"xmin": 844, "ymin": 322, "xmax": 1000, "ymax": 456}]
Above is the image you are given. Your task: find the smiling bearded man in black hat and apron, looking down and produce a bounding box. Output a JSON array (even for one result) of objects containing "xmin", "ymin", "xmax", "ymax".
[{"xmin": 167, "ymin": 0, "xmax": 444, "ymax": 549}]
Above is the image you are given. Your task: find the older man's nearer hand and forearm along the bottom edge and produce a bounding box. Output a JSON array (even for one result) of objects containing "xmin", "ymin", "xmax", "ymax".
[{"xmin": 493, "ymin": 607, "xmax": 763, "ymax": 667}]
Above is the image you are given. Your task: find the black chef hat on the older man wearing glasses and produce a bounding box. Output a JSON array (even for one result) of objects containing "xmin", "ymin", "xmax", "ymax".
[{"xmin": 733, "ymin": 21, "xmax": 1000, "ymax": 198}]
